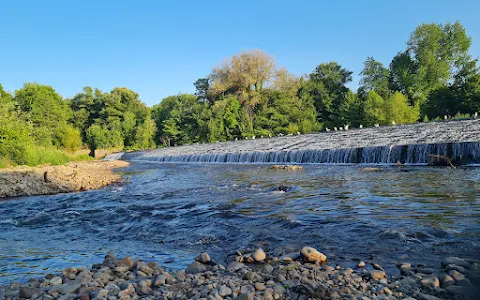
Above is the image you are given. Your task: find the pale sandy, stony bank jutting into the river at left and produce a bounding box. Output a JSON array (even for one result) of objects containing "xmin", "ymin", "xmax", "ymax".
[{"xmin": 0, "ymin": 161, "xmax": 129, "ymax": 198}]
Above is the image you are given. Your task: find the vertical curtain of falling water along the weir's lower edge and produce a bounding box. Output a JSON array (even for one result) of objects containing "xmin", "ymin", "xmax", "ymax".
[{"xmin": 123, "ymin": 142, "xmax": 480, "ymax": 164}]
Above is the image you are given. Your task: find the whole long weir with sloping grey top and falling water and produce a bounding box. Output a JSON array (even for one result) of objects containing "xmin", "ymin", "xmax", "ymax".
[{"xmin": 120, "ymin": 120, "xmax": 480, "ymax": 165}]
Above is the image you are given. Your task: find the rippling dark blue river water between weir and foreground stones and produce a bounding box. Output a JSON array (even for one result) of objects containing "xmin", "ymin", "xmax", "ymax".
[{"xmin": 0, "ymin": 162, "xmax": 480, "ymax": 283}]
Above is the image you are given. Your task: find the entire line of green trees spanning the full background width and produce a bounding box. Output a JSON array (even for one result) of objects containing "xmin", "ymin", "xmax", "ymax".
[{"xmin": 0, "ymin": 22, "xmax": 480, "ymax": 164}]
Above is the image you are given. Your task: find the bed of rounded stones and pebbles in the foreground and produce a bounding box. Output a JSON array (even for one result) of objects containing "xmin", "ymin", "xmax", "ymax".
[{"xmin": 0, "ymin": 247, "xmax": 480, "ymax": 300}]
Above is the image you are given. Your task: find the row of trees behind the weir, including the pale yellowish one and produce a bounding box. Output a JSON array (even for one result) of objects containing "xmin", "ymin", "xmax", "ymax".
[{"xmin": 152, "ymin": 22, "xmax": 480, "ymax": 146}]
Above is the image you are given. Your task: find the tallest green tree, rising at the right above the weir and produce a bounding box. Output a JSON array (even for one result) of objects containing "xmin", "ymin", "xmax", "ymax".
[{"xmin": 390, "ymin": 22, "xmax": 471, "ymax": 109}]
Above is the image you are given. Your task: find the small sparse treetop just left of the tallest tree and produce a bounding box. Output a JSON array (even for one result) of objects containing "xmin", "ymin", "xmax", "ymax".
[{"xmin": 358, "ymin": 57, "xmax": 390, "ymax": 98}]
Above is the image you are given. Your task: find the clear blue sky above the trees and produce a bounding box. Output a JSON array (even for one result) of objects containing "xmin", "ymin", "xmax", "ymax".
[{"xmin": 0, "ymin": 0, "xmax": 480, "ymax": 106}]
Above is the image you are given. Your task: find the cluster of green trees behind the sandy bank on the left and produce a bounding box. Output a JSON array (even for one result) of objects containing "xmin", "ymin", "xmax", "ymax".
[{"xmin": 0, "ymin": 83, "xmax": 156, "ymax": 166}]
